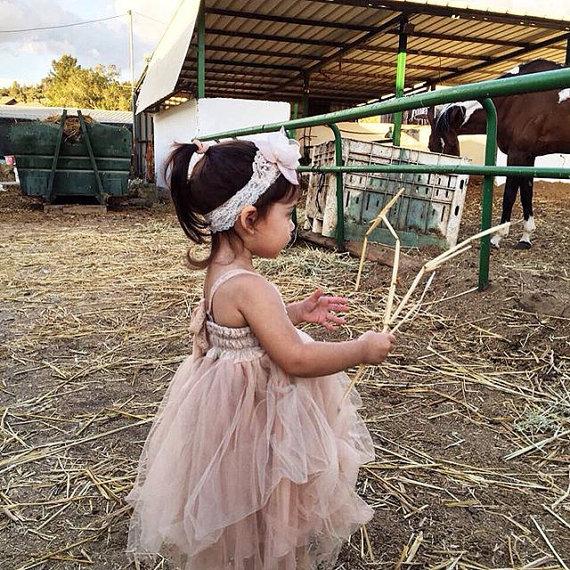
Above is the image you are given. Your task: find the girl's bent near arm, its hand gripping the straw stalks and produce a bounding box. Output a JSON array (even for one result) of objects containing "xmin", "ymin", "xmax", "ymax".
[{"xmin": 234, "ymin": 276, "xmax": 394, "ymax": 377}]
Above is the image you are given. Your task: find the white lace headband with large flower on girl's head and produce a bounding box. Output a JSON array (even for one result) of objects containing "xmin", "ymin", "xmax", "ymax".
[{"xmin": 204, "ymin": 128, "xmax": 301, "ymax": 233}]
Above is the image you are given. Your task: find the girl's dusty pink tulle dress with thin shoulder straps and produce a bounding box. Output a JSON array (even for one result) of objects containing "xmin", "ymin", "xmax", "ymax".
[{"xmin": 126, "ymin": 270, "xmax": 374, "ymax": 570}]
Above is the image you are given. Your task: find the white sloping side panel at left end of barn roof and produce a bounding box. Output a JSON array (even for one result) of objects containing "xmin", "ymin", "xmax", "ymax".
[{"xmin": 137, "ymin": 0, "xmax": 200, "ymax": 113}]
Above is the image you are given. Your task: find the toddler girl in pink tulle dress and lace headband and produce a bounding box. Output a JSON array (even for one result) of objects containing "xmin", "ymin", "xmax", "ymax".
[{"xmin": 127, "ymin": 131, "xmax": 394, "ymax": 570}]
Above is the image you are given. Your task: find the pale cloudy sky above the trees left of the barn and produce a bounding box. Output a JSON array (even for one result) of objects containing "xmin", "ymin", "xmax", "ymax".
[{"xmin": 0, "ymin": 0, "xmax": 179, "ymax": 87}]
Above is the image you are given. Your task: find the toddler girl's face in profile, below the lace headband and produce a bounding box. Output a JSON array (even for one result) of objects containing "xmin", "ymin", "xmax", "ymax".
[{"xmin": 253, "ymin": 198, "xmax": 297, "ymax": 258}]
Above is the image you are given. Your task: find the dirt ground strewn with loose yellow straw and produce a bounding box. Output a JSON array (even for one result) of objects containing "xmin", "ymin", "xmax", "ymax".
[{"xmin": 0, "ymin": 181, "xmax": 570, "ymax": 570}]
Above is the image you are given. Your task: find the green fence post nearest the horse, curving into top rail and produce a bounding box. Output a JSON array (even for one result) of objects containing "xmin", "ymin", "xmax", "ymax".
[{"xmin": 479, "ymin": 99, "xmax": 497, "ymax": 291}]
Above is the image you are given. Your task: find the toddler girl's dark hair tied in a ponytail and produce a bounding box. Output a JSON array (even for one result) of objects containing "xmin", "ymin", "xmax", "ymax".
[{"xmin": 165, "ymin": 140, "xmax": 298, "ymax": 269}]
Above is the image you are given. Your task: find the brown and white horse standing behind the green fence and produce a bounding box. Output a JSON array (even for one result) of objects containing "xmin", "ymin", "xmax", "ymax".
[{"xmin": 428, "ymin": 59, "xmax": 570, "ymax": 249}]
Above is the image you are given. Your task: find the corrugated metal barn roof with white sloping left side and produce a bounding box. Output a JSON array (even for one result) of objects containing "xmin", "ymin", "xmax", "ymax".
[{"xmin": 137, "ymin": 0, "xmax": 570, "ymax": 112}]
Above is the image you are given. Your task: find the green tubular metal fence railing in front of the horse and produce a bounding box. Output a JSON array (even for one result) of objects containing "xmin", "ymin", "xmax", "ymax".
[{"xmin": 201, "ymin": 68, "xmax": 570, "ymax": 289}]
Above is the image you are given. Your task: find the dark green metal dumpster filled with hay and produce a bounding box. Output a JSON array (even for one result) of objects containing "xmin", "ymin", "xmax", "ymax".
[{"xmin": 9, "ymin": 110, "xmax": 132, "ymax": 204}]
